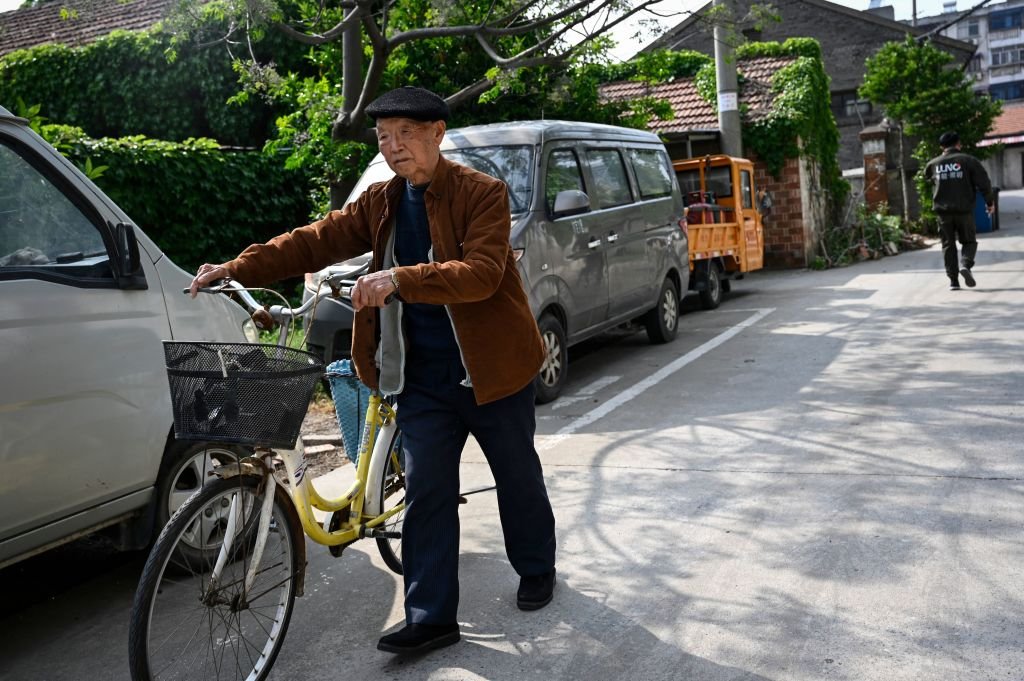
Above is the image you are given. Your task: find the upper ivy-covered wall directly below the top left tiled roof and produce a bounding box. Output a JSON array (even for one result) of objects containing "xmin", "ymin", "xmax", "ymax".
[{"xmin": 0, "ymin": 31, "xmax": 274, "ymax": 146}]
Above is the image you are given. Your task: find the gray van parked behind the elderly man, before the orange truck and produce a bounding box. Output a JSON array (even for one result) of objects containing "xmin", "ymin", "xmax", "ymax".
[{"xmin": 306, "ymin": 121, "xmax": 689, "ymax": 402}]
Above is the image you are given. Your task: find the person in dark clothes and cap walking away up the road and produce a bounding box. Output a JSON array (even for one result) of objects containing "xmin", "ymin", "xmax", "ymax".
[{"xmin": 925, "ymin": 132, "xmax": 994, "ymax": 291}]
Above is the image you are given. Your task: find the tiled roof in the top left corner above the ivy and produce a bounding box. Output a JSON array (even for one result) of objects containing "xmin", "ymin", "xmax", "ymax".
[{"xmin": 0, "ymin": 0, "xmax": 175, "ymax": 55}]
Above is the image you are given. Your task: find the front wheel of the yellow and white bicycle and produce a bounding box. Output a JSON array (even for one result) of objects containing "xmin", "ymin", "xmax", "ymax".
[{"xmin": 128, "ymin": 475, "xmax": 302, "ymax": 681}]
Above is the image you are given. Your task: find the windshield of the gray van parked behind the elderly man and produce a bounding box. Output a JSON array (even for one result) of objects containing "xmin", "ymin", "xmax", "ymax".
[{"xmin": 348, "ymin": 144, "xmax": 534, "ymax": 215}]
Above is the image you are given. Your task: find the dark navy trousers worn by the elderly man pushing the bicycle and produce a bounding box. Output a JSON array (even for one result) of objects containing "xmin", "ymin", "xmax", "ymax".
[{"xmin": 398, "ymin": 359, "xmax": 555, "ymax": 625}]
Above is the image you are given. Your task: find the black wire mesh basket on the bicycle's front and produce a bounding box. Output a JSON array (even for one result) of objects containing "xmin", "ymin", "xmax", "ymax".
[{"xmin": 164, "ymin": 341, "xmax": 324, "ymax": 450}]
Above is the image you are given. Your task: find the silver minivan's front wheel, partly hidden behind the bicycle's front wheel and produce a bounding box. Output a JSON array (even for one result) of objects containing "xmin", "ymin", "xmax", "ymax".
[{"xmin": 156, "ymin": 440, "xmax": 251, "ymax": 534}]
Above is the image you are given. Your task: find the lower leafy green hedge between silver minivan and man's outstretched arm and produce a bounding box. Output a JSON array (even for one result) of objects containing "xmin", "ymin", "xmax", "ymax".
[{"xmin": 42, "ymin": 125, "xmax": 310, "ymax": 271}]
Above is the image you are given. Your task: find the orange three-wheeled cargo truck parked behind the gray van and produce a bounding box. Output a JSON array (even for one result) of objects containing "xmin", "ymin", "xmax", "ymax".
[{"xmin": 672, "ymin": 155, "xmax": 764, "ymax": 309}]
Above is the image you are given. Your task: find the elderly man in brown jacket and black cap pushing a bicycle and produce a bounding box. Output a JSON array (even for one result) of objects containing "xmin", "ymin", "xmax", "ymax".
[{"xmin": 193, "ymin": 87, "xmax": 555, "ymax": 653}]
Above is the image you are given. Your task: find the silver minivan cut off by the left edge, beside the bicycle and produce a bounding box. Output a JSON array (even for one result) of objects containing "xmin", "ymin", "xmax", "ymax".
[{"xmin": 0, "ymin": 107, "xmax": 256, "ymax": 567}]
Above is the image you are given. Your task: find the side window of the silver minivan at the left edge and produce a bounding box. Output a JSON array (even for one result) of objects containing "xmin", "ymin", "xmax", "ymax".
[{"xmin": 0, "ymin": 142, "xmax": 110, "ymax": 276}]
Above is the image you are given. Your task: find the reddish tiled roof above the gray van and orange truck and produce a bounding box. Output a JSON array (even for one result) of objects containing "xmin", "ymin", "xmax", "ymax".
[{"xmin": 601, "ymin": 56, "xmax": 796, "ymax": 134}]
